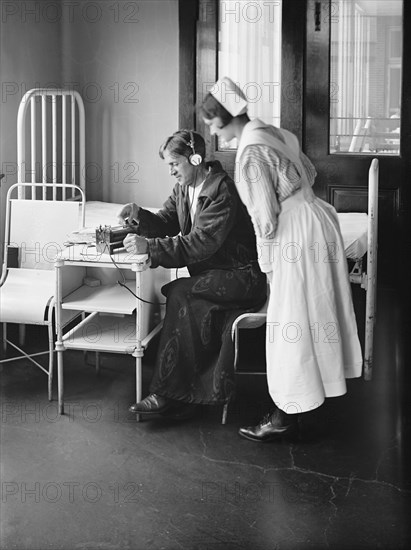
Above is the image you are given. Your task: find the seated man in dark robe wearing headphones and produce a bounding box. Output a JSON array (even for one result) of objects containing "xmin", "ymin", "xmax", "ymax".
[{"xmin": 120, "ymin": 130, "xmax": 267, "ymax": 418}]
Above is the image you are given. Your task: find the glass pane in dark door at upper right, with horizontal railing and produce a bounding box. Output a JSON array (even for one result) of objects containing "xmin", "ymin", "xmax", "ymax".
[{"xmin": 330, "ymin": 0, "xmax": 403, "ymax": 155}]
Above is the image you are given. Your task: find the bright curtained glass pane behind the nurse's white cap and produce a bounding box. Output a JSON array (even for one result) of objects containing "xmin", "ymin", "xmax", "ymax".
[{"xmin": 218, "ymin": 0, "xmax": 282, "ymax": 150}]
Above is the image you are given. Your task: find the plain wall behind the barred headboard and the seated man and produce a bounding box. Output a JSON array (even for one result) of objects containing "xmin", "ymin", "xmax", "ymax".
[{"xmin": 0, "ymin": 0, "xmax": 178, "ymax": 222}]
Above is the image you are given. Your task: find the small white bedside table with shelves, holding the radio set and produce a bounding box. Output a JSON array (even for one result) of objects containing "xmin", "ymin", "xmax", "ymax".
[{"xmin": 55, "ymin": 245, "xmax": 161, "ymax": 420}]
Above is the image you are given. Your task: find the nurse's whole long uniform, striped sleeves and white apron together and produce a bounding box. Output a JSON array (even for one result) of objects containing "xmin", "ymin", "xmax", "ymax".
[{"xmin": 236, "ymin": 119, "xmax": 362, "ymax": 414}]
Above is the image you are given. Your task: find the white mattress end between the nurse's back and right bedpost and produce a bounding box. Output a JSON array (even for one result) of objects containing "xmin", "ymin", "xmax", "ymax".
[{"xmin": 338, "ymin": 212, "xmax": 368, "ymax": 260}]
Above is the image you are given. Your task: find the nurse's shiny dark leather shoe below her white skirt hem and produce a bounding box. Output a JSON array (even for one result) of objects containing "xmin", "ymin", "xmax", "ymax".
[{"xmin": 238, "ymin": 409, "xmax": 298, "ymax": 441}]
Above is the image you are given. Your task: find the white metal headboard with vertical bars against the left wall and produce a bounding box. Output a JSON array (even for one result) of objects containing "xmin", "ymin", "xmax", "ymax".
[{"xmin": 17, "ymin": 88, "xmax": 86, "ymax": 200}]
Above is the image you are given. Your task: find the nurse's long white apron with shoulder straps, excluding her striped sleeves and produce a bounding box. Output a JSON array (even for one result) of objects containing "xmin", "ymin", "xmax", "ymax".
[{"xmin": 236, "ymin": 120, "xmax": 362, "ymax": 413}]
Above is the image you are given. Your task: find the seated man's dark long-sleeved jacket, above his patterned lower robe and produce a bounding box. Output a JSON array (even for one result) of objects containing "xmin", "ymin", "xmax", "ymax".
[{"xmin": 136, "ymin": 161, "xmax": 257, "ymax": 275}]
